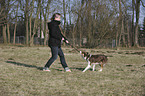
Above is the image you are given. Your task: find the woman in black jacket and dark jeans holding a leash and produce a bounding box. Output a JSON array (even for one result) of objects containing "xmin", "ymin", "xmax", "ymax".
[{"xmin": 43, "ymin": 13, "xmax": 71, "ymax": 72}]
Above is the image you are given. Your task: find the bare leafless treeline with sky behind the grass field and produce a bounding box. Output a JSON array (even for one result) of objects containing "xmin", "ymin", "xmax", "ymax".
[{"xmin": 0, "ymin": 0, "xmax": 145, "ymax": 48}]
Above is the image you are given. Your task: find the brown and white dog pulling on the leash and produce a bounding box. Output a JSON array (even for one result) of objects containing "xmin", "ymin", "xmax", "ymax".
[{"xmin": 80, "ymin": 51, "xmax": 108, "ymax": 72}]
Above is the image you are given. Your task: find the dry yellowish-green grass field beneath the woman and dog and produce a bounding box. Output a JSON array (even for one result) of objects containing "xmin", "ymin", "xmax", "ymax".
[{"xmin": 0, "ymin": 45, "xmax": 145, "ymax": 96}]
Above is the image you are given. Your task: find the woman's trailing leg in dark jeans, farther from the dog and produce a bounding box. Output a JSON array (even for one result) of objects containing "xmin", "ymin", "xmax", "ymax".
[{"xmin": 45, "ymin": 47, "xmax": 58, "ymax": 68}]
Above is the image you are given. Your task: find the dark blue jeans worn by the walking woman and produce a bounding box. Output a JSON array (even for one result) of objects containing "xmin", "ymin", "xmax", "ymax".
[{"xmin": 45, "ymin": 47, "xmax": 68, "ymax": 68}]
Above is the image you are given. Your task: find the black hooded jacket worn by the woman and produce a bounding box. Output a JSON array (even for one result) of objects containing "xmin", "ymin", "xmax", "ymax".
[{"xmin": 48, "ymin": 20, "xmax": 66, "ymax": 47}]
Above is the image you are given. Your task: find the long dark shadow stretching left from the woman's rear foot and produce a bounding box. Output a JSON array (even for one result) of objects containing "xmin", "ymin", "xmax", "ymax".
[{"xmin": 6, "ymin": 61, "xmax": 43, "ymax": 70}]
